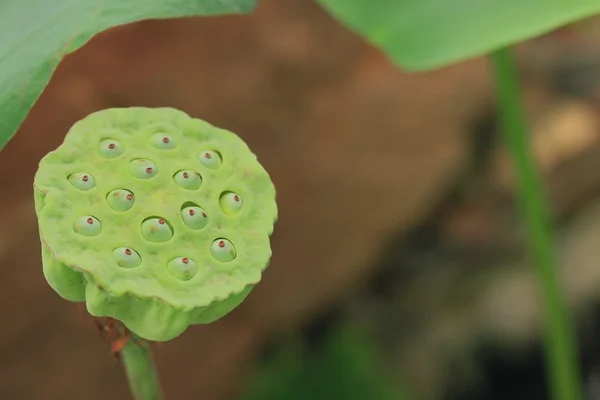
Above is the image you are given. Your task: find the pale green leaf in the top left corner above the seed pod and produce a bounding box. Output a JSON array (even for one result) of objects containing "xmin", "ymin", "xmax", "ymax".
[{"xmin": 0, "ymin": 0, "xmax": 256, "ymax": 150}]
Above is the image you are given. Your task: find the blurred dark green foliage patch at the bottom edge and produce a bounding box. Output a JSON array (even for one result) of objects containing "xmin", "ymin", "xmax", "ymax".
[{"xmin": 240, "ymin": 326, "xmax": 412, "ymax": 400}]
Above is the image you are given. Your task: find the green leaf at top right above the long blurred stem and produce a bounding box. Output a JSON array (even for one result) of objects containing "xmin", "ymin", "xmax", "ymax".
[{"xmin": 318, "ymin": 0, "xmax": 600, "ymax": 70}]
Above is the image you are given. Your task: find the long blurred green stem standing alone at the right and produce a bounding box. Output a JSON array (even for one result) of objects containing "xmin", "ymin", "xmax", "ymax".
[{"xmin": 492, "ymin": 49, "xmax": 583, "ymax": 400}]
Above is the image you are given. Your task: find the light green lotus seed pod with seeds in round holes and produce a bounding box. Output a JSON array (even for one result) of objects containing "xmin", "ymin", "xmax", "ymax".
[{"xmin": 34, "ymin": 107, "xmax": 277, "ymax": 341}]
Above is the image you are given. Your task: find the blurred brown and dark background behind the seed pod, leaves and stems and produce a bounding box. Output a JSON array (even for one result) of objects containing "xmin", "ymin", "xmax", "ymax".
[{"xmin": 5, "ymin": 0, "xmax": 600, "ymax": 400}]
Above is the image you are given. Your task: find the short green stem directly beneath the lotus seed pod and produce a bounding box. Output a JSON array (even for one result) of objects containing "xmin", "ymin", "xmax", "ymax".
[{"xmin": 121, "ymin": 337, "xmax": 164, "ymax": 400}]
